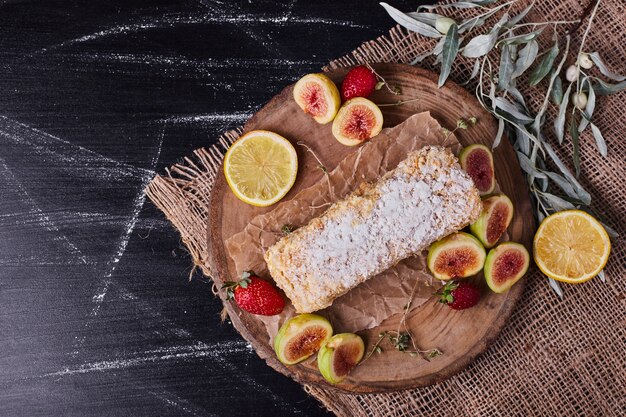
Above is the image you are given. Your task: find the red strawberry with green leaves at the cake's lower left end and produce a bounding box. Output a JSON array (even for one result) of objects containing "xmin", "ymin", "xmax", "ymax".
[{"xmin": 222, "ymin": 272, "xmax": 285, "ymax": 316}]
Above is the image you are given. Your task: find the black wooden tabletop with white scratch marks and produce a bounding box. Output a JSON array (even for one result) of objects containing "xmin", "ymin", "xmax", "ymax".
[{"xmin": 0, "ymin": 0, "xmax": 415, "ymax": 416}]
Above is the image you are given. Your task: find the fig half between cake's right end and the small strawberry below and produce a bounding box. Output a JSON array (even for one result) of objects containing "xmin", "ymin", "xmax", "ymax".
[{"xmin": 427, "ymin": 232, "xmax": 485, "ymax": 281}]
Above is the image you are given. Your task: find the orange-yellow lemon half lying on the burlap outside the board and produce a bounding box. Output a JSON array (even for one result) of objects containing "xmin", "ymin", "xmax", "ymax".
[{"xmin": 533, "ymin": 210, "xmax": 611, "ymax": 284}]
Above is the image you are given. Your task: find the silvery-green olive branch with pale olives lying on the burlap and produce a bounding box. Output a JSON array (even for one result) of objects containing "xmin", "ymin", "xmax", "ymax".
[{"xmin": 381, "ymin": 0, "xmax": 626, "ymax": 297}]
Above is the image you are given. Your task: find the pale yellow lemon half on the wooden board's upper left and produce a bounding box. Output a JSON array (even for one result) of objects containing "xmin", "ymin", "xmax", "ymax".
[{"xmin": 224, "ymin": 130, "xmax": 298, "ymax": 207}]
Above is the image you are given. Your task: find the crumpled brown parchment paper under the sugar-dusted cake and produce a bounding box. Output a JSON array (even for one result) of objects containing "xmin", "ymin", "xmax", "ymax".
[{"xmin": 226, "ymin": 112, "xmax": 461, "ymax": 340}]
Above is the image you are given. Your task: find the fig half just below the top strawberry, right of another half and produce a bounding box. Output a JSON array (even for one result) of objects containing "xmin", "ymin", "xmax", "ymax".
[{"xmin": 333, "ymin": 97, "xmax": 383, "ymax": 146}]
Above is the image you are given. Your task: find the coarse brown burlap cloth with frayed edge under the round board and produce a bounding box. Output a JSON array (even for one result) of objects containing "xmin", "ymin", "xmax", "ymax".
[{"xmin": 147, "ymin": 0, "xmax": 626, "ymax": 416}]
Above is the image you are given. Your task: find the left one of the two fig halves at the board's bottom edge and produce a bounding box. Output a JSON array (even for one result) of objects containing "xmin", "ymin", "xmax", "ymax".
[{"xmin": 274, "ymin": 314, "xmax": 333, "ymax": 365}]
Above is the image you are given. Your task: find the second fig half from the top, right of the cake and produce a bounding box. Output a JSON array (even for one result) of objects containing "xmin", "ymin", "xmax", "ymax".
[{"xmin": 470, "ymin": 194, "xmax": 513, "ymax": 248}]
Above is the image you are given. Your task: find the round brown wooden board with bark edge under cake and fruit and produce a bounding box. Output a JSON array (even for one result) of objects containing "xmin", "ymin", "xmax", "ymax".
[{"xmin": 209, "ymin": 64, "xmax": 535, "ymax": 393}]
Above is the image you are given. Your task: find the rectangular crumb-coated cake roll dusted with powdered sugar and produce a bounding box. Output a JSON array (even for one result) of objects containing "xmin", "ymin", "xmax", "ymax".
[{"xmin": 264, "ymin": 146, "xmax": 481, "ymax": 313}]
